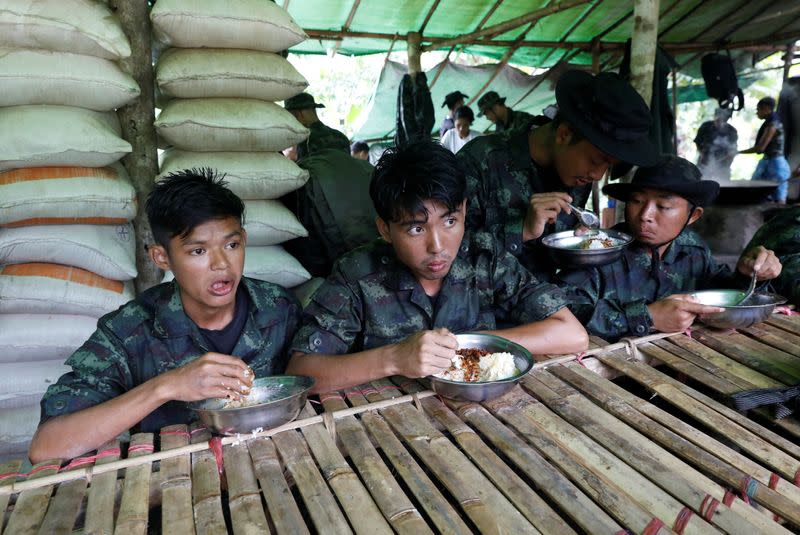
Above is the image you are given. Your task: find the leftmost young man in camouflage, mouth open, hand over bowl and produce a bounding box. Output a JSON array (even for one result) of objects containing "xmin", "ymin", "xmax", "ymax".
[{"xmin": 29, "ymin": 170, "xmax": 300, "ymax": 463}]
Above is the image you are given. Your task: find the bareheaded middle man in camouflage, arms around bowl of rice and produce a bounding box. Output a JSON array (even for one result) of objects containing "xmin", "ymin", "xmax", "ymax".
[{"xmin": 287, "ymin": 141, "xmax": 588, "ymax": 392}]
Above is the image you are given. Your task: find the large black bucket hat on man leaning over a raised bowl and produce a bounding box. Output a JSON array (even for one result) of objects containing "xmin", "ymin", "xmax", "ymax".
[{"xmin": 556, "ymin": 70, "xmax": 659, "ymax": 166}]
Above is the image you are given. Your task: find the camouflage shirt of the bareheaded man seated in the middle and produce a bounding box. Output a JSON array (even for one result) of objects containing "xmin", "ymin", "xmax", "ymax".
[{"xmin": 292, "ymin": 234, "xmax": 566, "ymax": 354}]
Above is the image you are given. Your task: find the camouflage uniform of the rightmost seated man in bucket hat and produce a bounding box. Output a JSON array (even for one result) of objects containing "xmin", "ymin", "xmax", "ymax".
[{"xmin": 557, "ymin": 223, "xmax": 744, "ymax": 342}]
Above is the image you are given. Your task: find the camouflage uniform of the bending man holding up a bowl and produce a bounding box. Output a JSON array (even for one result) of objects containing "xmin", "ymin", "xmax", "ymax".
[{"xmin": 456, "ymin": 131, "xmax": 591, "ymax": 280}]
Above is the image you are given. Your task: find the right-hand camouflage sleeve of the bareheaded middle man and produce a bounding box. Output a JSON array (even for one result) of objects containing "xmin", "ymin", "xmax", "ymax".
[{"xmin": 492, "ymin": 249, "xmax": 567, "ymax": 325}]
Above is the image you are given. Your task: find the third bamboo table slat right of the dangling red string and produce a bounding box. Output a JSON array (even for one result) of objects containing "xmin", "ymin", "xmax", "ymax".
[{"xmin": 272, "ymin": 430, "xmax": 353, "ymax": 533}]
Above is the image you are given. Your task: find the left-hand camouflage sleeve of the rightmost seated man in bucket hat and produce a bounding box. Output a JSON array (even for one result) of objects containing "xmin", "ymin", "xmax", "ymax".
[{"xmin": 558, "ymin": 268, "xmax": 653, "ymax": 341}]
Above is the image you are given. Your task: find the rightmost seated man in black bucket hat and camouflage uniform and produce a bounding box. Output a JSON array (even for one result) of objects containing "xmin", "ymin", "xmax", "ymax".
[{"xmin": 558, "ymin": 156, "xmax": 781, "ymax": 341}]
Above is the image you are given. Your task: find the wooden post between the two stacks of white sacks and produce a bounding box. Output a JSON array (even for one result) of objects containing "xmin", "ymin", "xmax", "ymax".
[{"xmin": 108, "ymin": 0, "xmax": 161, "ymax": 292}]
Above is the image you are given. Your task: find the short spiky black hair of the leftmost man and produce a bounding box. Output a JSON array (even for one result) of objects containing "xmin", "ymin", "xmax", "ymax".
[{"xmin": 145, "ymin": 168, "xmax": 244, "ymax": 247}]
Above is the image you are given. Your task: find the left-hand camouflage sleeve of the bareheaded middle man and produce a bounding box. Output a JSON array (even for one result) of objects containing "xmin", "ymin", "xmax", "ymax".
[{"xmin": 289, "ymin": 264, "xmax": 362, "ymax": 355}]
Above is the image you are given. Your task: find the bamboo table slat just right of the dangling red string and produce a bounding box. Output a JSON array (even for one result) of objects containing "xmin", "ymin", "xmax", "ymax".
[{"xmin": 222, "ymin": 444, "xmax": 270, "ymax": 535}]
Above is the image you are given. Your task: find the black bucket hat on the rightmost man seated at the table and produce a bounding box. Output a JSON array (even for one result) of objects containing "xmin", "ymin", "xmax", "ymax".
[{"xmin": 603, "ymin": 154, "xmax": 719, "ymax": 207}]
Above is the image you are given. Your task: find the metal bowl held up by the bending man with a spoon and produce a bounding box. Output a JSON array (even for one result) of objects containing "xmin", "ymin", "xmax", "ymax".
[{"xmin": 542, "ymin": 229, "xmax": 633, "ymax": 268}]
